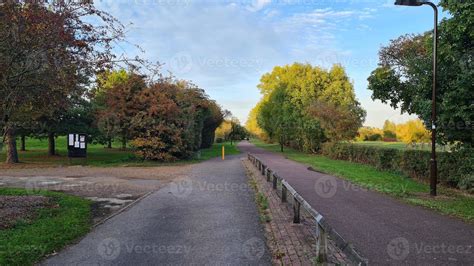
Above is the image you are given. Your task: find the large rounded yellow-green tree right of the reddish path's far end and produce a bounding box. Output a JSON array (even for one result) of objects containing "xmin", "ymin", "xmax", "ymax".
[{"xmin": 255, "ymin": 63, "xmax": 365, "ymax": 152}]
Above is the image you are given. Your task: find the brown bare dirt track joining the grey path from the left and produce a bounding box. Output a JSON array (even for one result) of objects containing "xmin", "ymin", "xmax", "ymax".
[{"xmin": 0, "ymin": 165, "xmax": 193, "ymax": 223}]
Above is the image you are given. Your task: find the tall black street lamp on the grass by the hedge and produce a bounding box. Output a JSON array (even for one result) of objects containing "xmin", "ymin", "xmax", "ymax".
[{"xmin": 395, "ymin": 0, "xmax": 438, "ymax": 196}]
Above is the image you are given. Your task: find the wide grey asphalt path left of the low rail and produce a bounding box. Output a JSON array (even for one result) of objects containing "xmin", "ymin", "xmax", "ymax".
[{"xmin": 43, "ymin": 156, "xmax": 271, "ymax": 265}]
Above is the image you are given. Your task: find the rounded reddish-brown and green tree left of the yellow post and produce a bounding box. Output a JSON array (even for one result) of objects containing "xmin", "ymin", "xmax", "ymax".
[{"xmin": 128, "ymin": 79, "xmax": 224, "ymax": 161}]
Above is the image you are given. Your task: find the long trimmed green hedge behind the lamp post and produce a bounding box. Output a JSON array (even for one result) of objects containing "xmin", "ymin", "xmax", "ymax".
[{"xmin": 321, "ymin": 143, "xmax": 474, "ymax": 193}]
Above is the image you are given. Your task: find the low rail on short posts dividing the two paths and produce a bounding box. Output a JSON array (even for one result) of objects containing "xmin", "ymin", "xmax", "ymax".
[{"xmin": 247, "ymin": 153, "xmax": 368, "ymax": 265}]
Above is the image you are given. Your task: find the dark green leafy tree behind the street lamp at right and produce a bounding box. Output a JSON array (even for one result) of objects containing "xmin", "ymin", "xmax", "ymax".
[{"xmin": 368, "ymin": 0, "xmax": 474, "ymax": 146}]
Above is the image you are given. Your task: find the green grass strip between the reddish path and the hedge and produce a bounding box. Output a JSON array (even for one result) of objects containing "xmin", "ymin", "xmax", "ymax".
[{"xmin": 252, "ymin": 140, "xmax": 474, "ymax": 223}]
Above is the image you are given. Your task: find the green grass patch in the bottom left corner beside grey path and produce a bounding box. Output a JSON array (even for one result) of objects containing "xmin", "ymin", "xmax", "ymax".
[{"xmin": 0, "ymin": 188, "xmax": 91, "ymax": 265}]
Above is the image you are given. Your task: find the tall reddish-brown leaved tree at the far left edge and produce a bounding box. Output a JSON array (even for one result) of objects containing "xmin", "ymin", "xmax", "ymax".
[{"xmin": 0, "ymin": 1, "xmax": 123, "ymax": 163}]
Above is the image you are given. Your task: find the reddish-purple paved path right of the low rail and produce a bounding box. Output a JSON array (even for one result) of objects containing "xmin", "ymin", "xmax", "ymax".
[{"xmin": 239, "ymin": 142, "xmax": 474, "ymax": 265}]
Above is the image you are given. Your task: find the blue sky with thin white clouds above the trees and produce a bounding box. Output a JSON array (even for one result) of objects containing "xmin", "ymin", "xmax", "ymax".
[{"xmin": 96, "ymin": 0, "xmax": 444, "ymax": 127}]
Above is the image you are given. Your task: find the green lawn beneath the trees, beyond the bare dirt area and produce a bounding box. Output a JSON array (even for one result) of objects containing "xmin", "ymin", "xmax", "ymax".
[{"xmin": 0, "ymin": 136, "xmax": 239, "ymax": 167}]
